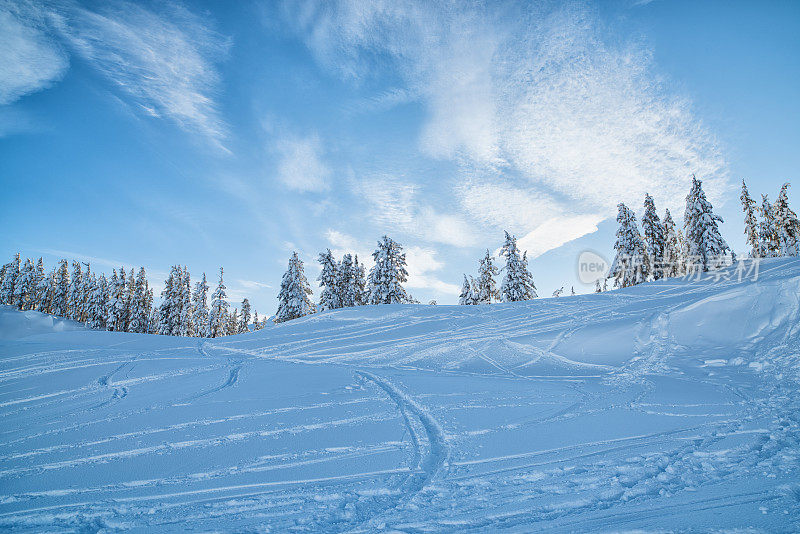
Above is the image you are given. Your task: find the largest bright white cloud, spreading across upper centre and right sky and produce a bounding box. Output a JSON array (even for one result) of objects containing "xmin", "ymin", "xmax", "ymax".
[{"xmin": 287, "ymin": 0, "xmax": 727, "ymax": 243}]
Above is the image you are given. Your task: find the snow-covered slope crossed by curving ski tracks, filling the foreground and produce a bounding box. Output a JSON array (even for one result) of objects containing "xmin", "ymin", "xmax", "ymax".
[{"xmin": 0, "ymin": 260, "xmax": 800, "ymax": 532}]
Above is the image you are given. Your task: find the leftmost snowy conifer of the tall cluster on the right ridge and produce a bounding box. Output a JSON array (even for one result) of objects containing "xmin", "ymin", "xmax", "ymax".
[{"xmin": 609, "ymin": 203, "xmax": 650, "ymax": 287}]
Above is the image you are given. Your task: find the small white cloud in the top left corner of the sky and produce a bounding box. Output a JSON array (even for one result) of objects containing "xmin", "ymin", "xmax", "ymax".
[{"xmin": 0, "ymin": 2, "xmax": 69, "ymax": 105}]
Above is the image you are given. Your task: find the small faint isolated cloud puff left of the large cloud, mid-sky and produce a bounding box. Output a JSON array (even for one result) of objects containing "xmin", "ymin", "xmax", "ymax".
[{"xmin": 276, "ymin": 135, "xmax": 331, "ymax": 192}]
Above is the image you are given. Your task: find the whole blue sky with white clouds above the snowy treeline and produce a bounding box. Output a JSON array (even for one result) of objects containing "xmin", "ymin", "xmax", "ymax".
[{"xmin": 0, "ymin": 0, "xmax": 800, "ymax": 314}]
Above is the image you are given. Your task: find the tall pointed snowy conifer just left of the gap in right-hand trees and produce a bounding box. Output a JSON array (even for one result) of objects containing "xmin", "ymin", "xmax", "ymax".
[{"xmin": 683, "ymin": 176, "xmax": 731, "ymax": 271}]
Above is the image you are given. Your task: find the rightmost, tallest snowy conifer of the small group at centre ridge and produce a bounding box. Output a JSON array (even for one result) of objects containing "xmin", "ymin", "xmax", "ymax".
[{"xmin": 369, "ymin": 236, "xmax": 411, "ymax": 304}]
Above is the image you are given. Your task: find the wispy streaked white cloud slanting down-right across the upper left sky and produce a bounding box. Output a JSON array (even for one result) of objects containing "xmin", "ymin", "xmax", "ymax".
[{"xmin": 53, "ymin": 2, "xmax": 229, "ymax": 149}]
